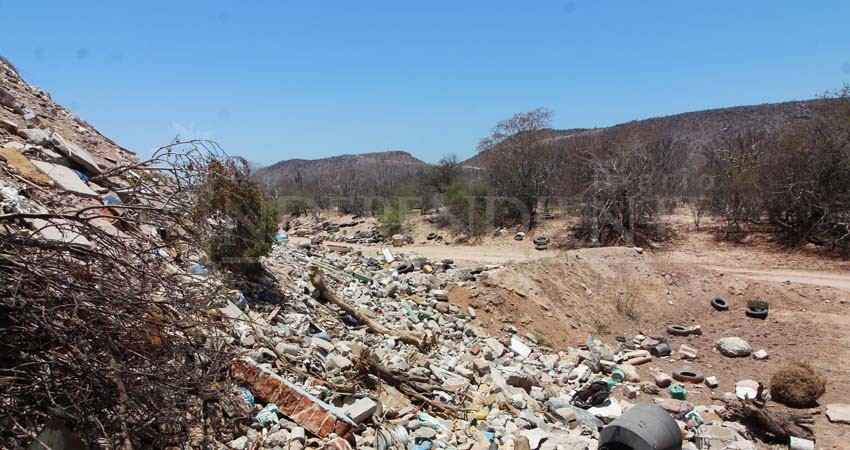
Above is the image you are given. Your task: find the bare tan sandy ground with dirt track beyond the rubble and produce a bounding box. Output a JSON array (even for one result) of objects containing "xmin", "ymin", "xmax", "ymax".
[{"xmin": 294, "ymin": 210, "xmax": 850, "ymax": 449}]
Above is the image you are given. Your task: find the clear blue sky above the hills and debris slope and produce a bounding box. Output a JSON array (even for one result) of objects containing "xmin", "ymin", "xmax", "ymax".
[{"xmin": 0, "ymin": 0, "xmax": 850, "ymax": 164}]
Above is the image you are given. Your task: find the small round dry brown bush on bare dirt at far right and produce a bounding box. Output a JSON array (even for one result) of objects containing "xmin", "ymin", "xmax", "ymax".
[{"xmin": 770, "ymin": 362, "xmax": 826, "ymax": 407}]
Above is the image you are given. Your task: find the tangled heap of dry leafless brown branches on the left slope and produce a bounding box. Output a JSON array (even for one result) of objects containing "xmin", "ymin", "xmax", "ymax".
[{"xmin": 0, "ymin": 142, "xmax": 248, "ymax": 449}]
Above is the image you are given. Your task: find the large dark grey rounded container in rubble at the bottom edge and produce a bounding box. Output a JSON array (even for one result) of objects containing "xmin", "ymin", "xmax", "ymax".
[{"xmin": 599, "ymin": 403, "xmax": 682, "ymax": 450}]
